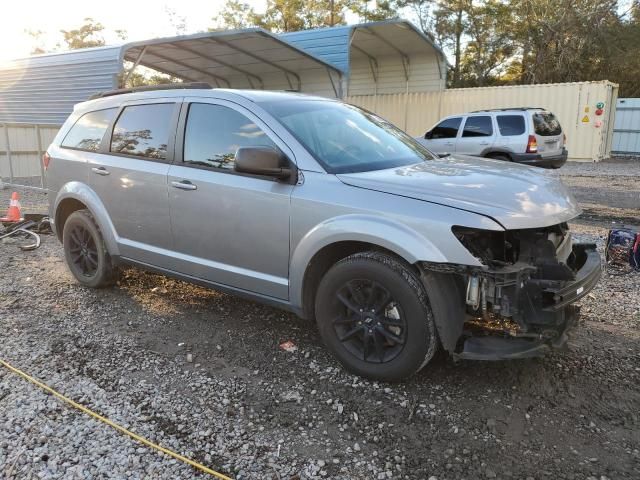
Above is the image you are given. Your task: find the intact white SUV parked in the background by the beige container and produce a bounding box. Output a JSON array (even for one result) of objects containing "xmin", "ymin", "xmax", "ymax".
[{"xmin": 417, "ymin": 107, "xmax": 567, "ymax": 168}]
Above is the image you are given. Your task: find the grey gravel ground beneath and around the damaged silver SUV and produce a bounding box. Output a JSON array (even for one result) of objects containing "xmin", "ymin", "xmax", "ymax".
[{"xmin": 0, "ymin": 159, "xmax": 640, "ymax": 480}]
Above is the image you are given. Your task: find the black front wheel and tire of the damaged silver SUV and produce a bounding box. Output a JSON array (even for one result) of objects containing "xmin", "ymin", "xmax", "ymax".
[{"xmin": 315, "ymin": 252, "xmax": 438, "ymax": 381}]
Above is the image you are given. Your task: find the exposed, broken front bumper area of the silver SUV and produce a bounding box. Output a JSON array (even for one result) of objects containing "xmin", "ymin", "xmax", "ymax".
[{"xmin": 427, "ymin": 244, "xmax": 601, "ymax": 360}]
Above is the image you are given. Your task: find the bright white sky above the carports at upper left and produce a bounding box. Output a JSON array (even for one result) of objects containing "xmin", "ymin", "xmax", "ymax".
[{"xmin": 0, "ymin": 0, "xmax": 266, "ymax": 60}]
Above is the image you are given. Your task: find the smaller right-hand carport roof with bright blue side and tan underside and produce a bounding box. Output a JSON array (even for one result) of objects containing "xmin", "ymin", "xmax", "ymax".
[{"xmin": 280, "ymin": 19, "xmax": 447, "ymax": 74}]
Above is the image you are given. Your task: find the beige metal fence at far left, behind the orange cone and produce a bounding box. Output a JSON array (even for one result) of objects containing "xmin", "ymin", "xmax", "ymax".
[{"xmin": 0, "ymin": 123, "xmax": 60, "ymax": 190}]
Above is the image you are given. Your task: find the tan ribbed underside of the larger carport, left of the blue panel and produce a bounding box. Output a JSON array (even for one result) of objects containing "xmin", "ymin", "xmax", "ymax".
[{"xmin": 121, "ymin": 28, "xmax": 342, "ymax": 97}]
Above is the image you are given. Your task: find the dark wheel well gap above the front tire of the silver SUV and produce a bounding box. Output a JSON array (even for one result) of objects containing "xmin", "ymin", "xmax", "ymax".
[{"xmin": 302, "ymin": 241, "xmax": 417, "ymax": 321}]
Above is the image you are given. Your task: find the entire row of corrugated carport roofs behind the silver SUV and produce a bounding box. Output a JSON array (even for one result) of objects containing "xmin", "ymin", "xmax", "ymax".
[{"xmin": 0, "ymin": 20, "xmax": 444, "ymax": 124}]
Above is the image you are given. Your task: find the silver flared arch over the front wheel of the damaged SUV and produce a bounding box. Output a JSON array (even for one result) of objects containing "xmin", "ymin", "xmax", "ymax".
[{"xmin": 289, "ymin": 214, "xmax": 447, "ymax": 307}]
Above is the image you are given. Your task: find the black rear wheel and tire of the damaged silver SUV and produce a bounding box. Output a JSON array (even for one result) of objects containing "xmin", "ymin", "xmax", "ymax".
[{"xmin": 62, "ymin": 210, "xmax": 116, "ymax": 288}]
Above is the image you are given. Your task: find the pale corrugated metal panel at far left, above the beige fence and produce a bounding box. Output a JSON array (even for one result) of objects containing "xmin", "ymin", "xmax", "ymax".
[{"xmin": 0, "ymin": 46, "xmax": 122, "ymax": 124}]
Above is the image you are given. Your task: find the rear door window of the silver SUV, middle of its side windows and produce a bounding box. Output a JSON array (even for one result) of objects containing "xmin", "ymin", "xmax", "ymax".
[{"xmin": 111, "ymin": 103, "xmax": 175, "ymax": 160}]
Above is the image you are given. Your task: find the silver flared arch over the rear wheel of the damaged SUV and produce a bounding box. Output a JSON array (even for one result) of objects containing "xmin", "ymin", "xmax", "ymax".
[{"xmin": 52, "ymin": 182, "xmax": 120, "ymax": 256}]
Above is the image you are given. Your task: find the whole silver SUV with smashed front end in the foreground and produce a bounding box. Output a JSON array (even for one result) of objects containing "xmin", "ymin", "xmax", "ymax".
[{"xmin": 45, "ymin": 85, "xmax": 600, "ymax": 380}]
